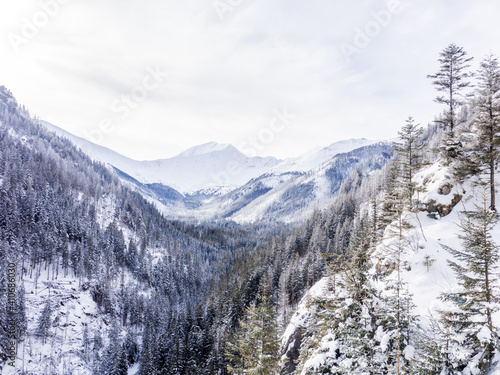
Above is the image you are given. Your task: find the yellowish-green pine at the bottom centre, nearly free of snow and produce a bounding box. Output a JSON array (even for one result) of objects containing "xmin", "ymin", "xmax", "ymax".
[{"xmin": 226, "ymin": 292, "xmax": 279, "ymax": 375}]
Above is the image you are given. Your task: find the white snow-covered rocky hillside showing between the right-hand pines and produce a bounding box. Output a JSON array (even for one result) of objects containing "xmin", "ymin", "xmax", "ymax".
[{"xmin": 282, "ymin": 162, "xmax": 500, "ymax": 375}]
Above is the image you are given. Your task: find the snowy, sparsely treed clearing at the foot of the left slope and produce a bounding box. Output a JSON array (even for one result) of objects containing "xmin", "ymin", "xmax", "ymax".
[{"xmin": 2, "ymin": 269, "xmax": 101, "ymax": 375}]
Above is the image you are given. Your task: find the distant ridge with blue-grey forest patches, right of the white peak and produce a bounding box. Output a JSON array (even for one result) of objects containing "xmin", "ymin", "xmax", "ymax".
[{"xmin": 193, "ymin": 139, "xmax": 392, "ymax": 223}]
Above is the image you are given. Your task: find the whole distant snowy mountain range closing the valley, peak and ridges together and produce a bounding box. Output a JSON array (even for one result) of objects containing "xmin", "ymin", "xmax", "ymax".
[{"xmin": 43, "ymin": 122, "xmax": 392, "ymax": 223}]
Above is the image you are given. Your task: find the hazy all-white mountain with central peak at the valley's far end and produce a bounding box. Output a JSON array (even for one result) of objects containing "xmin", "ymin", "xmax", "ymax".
[{"xmin": 41, "ymin": 121, "xmax": 280, "ymax": 194}]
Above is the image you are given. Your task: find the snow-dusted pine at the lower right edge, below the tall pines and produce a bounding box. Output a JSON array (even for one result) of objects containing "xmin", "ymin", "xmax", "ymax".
[{"xmin": 442, "ymin": 194, "xmax": 500, "ymax": 372}]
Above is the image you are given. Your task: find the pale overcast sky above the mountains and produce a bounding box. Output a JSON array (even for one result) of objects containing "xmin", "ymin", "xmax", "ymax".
[{"xmin": 0, "ymin": 0, "xmax": 500, "ymax": 160}]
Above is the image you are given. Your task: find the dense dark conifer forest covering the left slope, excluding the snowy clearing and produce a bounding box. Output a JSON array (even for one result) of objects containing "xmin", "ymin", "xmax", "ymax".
[{"xmin": 0, "ymin": 88, "xmax": 264, "ymax": 374}]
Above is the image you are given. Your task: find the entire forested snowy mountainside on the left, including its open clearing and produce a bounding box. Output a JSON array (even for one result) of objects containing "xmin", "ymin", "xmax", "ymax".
[{"xmin": 0, "ymin": 87, "xmax": 270, "ymax": 375}]
